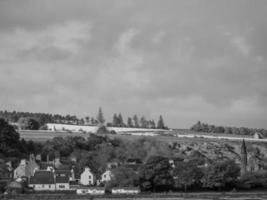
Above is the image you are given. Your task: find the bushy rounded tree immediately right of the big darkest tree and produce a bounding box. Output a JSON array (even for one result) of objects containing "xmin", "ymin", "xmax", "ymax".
[{"xmin": 173, "ymin": 160, "xmax": 203, "ymax": 192}]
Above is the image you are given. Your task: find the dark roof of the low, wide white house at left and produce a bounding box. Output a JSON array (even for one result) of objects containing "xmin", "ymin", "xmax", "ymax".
[{"xmin": 30, "ymin": 170, "xmax": 55, "ymax": 184}]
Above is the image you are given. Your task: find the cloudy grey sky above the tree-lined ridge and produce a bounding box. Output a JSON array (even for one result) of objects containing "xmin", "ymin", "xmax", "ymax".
[{"xmin": 0, "ymin": 0, "xmax": 267, "ymax": 128}]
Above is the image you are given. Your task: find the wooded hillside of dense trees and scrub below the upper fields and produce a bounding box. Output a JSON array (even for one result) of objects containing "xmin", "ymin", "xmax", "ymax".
[{"xmin": 0, "ymin": 119, "xmax": 267, "ymax": 192}]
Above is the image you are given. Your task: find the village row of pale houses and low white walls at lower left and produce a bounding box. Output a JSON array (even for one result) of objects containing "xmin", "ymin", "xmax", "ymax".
[{"xmin": 7, "ymin": 155, "xmax": 139, "ymax": 194}]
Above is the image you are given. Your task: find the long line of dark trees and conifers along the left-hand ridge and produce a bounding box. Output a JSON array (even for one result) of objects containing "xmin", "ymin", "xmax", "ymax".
[{"xmin": 0, "ymin": 110, "xmax": 167, "ymax": 130}]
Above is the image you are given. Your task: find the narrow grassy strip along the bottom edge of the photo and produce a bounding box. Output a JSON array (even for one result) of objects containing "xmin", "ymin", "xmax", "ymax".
[{"xmin": 0, "ymin": 192, "xmax": 267, "ymax": 200}]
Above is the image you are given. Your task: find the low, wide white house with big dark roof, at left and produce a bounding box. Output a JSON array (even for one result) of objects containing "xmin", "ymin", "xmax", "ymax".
[{"xmin": 29, "ymin": 170, "xmax": 56, "ymax": 191}]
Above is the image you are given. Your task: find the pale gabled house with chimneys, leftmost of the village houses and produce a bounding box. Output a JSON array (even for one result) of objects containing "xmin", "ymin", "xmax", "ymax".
[{"xmin": 14, "ymin": 154, "xmax": 39, "ymax": 179}]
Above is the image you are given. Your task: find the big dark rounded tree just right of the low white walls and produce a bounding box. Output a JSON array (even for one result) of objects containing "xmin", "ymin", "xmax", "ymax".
[{"xmin": 139, "ymin": 156, "xmax": 173, "ymax": 192}]
